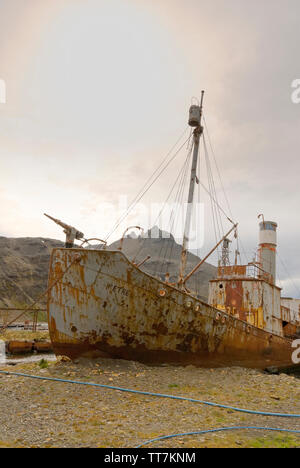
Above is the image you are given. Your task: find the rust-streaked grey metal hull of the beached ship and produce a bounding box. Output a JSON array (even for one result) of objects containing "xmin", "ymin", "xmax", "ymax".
[{"xmin": 48, "ymin": 249, "xmax": 294, "ymax": 369}]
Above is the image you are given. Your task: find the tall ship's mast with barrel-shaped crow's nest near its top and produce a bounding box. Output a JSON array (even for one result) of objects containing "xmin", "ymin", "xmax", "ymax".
[{"xmin": 179, "ymin": 91, "xmax": 204, "ymax": 284}]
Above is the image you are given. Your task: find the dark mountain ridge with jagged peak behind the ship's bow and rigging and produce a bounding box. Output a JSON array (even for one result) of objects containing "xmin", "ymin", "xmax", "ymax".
[{"xmin": 0, "ymin": 235, "xmax": 216, "ymax": 307}]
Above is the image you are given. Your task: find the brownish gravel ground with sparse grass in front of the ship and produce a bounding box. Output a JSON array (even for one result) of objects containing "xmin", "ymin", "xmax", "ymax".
[{"xmin": 0, "ymin": 352, "xmax": 300, "ymax": 448}]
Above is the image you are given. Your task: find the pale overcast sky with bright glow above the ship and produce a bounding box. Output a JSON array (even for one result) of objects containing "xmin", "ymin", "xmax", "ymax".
[{"xmin": 0, "ymin": 0, "xmax": 300, "ymax": 297}]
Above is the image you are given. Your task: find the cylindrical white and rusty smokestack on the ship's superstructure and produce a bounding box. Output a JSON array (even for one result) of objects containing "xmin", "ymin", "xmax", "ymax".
[{"xmin": 258, "ymin": 221, "xmax": 277, "ymax": 284}]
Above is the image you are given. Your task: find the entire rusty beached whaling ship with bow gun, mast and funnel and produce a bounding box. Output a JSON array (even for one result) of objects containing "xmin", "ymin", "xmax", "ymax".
[{"xmin": 48, "ymin": 94, "xmax": 300, "ymax": 369}]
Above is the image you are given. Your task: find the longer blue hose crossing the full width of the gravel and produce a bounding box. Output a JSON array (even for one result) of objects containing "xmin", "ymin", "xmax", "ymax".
[{"xmin": 0, "ymin": 371, "xmax": 300, "ymax": 418}]
